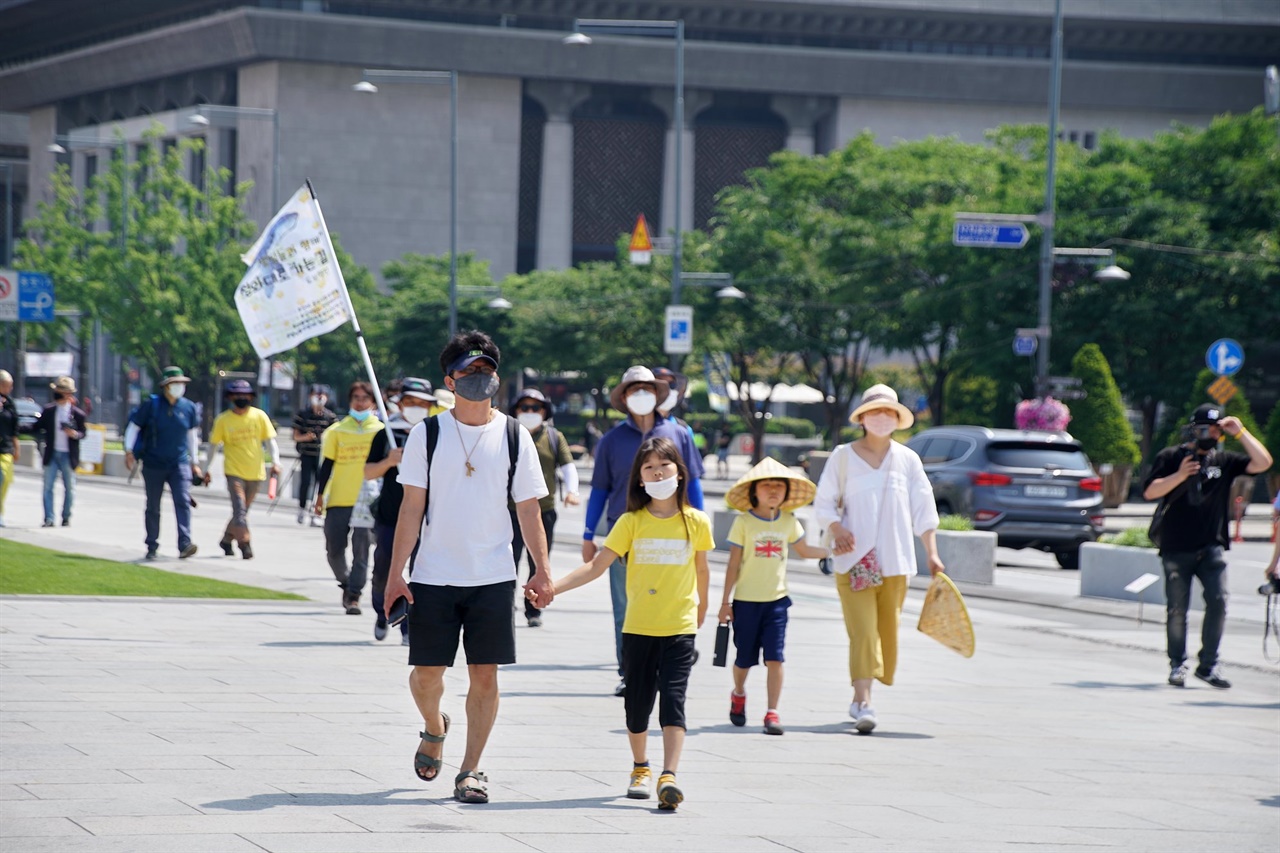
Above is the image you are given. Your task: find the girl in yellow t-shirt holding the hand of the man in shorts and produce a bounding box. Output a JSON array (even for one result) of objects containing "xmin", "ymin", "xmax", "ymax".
[{"xmin": 556, "ymin": 438, "xmax": 716, "ymax": 811}]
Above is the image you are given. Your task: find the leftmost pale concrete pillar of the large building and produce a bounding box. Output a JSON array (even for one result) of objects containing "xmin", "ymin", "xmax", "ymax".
[{"xmin": 525, "ymin": 81, "xmax": 591, "ymax": 269}]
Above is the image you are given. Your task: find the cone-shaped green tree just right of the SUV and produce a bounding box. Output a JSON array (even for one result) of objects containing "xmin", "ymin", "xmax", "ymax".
[{"xmin": 1070, "ymin": 343, "xmax": 1142, "ymax": 467}]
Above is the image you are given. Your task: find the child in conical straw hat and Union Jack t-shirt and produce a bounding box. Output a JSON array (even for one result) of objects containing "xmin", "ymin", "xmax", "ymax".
[{"xmin": 719, "ymin": 456, "xmax": 831, "ymax": 735}]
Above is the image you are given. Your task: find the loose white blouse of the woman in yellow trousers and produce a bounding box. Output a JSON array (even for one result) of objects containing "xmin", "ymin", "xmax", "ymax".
[{"xmin": 814, "ymin": 442, "xmax": 938, "ymax": 576}]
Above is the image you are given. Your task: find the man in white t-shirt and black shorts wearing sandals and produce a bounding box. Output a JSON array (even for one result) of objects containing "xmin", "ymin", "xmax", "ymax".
[{"xmin": 384, "ymin": 330, "xmax": 554, "ymax": 803}]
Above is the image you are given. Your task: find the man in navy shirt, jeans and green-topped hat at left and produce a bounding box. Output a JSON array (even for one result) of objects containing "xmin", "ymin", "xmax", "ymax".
[{"xmin": 124, "ymin": 366, "xmax": 204, "ymax": 560}]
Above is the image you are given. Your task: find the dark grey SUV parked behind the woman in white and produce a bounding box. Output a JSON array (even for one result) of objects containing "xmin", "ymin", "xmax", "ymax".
[{"xmin": 906, "ymin": 427, "xmax": 1103, "ymax": 569}]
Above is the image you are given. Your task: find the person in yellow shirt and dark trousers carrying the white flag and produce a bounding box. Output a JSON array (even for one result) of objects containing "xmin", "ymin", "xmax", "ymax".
[{"xmin": 315, "ymin": 380, "xmax": 383, "ymax": 616}]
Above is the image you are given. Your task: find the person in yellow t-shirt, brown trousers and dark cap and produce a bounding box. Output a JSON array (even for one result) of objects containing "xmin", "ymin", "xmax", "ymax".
[{"xmin": 205, "ymin": 379, "xmax": 280, "ymax": 560}]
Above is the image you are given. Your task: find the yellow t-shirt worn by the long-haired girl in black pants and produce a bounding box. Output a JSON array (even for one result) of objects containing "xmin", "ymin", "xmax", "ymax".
[{"xmin": 604, "ymin": 507, "xmax": 716, "ymax": 637}]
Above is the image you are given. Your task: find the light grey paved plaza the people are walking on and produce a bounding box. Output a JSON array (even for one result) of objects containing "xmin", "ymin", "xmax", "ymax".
[{"xmin": 0, "ymin": 473, "xmax": 1280, "ymax": 853}]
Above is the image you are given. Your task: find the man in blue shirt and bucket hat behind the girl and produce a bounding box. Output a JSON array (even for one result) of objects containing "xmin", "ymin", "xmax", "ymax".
[{"xmin": 582, "ymin": 365, "xmax": 703, "ymax": 695}]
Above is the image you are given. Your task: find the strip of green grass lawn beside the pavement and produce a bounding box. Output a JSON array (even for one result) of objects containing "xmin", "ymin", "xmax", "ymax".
[{"xmin": 0, "ymin": 539, "xmax": 306, "ymax": 601}]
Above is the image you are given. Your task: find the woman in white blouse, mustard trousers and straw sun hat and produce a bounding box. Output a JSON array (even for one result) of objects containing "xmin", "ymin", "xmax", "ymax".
[{"xmin": 814, "ymin": 386, "xmax": 945, "ymax": 734}]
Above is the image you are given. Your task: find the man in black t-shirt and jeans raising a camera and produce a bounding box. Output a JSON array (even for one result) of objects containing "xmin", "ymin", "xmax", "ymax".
[{"xmin": 1142, "ymin": 403, "xmax": 1271, "ymax": 690}]
